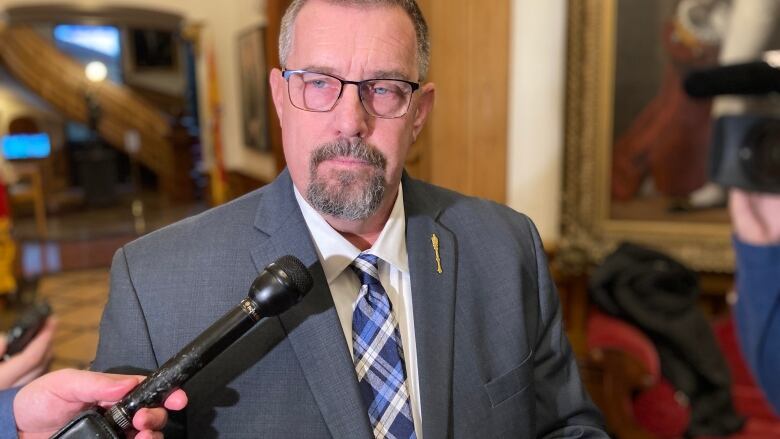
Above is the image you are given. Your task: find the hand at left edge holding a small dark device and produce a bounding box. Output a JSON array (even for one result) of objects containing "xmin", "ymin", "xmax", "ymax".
[{"xmin": 0, "ymin": 317, "xmax": 56, "ymax": 389}]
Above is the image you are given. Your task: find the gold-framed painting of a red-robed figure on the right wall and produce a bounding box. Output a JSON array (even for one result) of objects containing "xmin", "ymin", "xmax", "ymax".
[{"xmin": 560, "ymin": 0, "xmax": 734, "ymax": 272}]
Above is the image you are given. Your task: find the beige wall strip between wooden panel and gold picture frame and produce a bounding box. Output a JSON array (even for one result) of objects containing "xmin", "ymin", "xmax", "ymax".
[{"xmin": 507, "ymin": 0, "xmax": 566, "ymax": 244}]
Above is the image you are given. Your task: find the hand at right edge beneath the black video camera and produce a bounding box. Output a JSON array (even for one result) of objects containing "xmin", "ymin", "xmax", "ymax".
[{"xmin": 729, "ymin": 189, "xmax": 780, "ymax": 245}]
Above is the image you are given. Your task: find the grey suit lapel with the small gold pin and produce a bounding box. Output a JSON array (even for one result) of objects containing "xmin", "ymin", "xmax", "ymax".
[{"xmin": 404, "ymin": 176, "xmax": 457, "ymax": 439}]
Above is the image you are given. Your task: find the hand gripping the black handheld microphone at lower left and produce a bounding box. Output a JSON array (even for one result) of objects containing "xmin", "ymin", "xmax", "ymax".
[{"xmin": 14, "ymin": 369, "xmax": 187, "ymax": 439}]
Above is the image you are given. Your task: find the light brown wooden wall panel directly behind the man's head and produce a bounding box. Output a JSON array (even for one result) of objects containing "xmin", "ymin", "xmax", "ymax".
[{"xmin": 408, "ymin": 0, "xmax": 511, "ymax": 203}]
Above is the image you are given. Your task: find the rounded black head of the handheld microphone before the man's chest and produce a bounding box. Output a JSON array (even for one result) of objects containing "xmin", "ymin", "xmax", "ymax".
[{"xmin": 249, "ymin": 255, "xmax": 314, "ymax": 317}]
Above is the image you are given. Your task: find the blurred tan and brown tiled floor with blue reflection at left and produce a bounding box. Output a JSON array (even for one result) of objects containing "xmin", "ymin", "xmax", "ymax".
[{"xmin": 0, "ymin": 194, "xmax": 209, "ymax": 369}]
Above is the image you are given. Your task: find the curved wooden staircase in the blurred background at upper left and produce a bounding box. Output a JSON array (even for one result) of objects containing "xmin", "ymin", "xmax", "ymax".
[{"xmin": 0, "ymin": 26, "xmax": 192, "ymax": 200}]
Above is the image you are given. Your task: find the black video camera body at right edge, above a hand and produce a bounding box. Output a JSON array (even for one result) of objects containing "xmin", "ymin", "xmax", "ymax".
[{"xmin": 709, "ymin": 114, "xmax": 780, "ymax": 193}]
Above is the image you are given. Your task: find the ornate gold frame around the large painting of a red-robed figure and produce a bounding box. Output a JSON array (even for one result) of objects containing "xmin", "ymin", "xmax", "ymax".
[{"xmin": 560, "ymin": 0, "xmax": 734, "ymax": 272}]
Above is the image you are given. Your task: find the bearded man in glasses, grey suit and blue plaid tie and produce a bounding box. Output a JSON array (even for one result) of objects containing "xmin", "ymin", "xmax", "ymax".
[{"xmin": 94, "ymin": 0, "xmax": 606, "ymax": 439}]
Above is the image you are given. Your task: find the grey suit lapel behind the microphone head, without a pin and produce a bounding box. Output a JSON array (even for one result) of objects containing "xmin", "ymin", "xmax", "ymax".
[{"xmin": 252, "ymin": 170, "xmax": 372, "ymax": 438}]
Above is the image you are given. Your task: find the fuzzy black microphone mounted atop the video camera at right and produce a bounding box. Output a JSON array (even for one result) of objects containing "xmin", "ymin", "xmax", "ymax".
[{"xmin": 683, "ymin": 61, "xmax": 780, "ymax": 98}]
